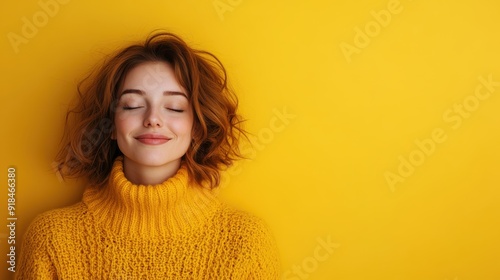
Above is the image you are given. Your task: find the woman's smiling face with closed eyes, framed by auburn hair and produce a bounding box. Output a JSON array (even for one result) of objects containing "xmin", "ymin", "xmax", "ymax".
[{"xmin": 113, "ymin": 62, "xmax": 193, "ymax": 173}]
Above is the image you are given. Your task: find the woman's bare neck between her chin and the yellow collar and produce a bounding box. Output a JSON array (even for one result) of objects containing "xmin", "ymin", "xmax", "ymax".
[{"xmin": 123, "ymin": 157, "xmax": 181, "ymax": 186}]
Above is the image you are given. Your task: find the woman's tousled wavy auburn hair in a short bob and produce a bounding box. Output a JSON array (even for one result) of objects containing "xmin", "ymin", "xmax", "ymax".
[{"xmin": 56, "ymin": 31, "xmax": 246, "ymax": 188}]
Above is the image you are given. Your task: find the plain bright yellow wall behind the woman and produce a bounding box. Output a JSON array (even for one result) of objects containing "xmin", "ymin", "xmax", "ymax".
[{"xmin": 0, "ymin": 0, "xmax": 500, "ymax": 280}]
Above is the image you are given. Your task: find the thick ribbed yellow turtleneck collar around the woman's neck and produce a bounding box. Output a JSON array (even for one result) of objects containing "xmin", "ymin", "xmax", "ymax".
[{"xmin": 83, "ymin": 157, "xmax": 219, "ymax": 237}]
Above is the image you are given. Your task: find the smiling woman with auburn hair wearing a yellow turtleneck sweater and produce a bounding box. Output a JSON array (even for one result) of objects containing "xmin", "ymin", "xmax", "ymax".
[{"xmin": 16, "ymin": 33, "xmax": 279, "ymax": 280}]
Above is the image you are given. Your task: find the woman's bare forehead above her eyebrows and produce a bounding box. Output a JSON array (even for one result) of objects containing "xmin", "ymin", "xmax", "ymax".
[{"xmin": 119, "ymin": 61, "xmax": 186, "ymax": 95}]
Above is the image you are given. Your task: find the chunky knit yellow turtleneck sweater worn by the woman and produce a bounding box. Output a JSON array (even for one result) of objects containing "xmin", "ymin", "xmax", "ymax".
[{"xmin": 16, "ymin": 157, "xmax": 280, "ymax": 280}]
